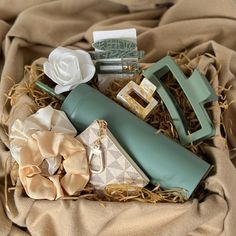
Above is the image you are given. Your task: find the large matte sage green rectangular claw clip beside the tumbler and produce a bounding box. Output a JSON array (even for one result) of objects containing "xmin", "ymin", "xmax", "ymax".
[{"xmin": 144, "ymin": 56, "xmax": 218, "ymax": 145}]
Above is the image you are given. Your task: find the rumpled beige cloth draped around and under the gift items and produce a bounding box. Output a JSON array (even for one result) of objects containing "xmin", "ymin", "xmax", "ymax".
[{"xmin": 0, "ymin": 0, "xmax": 236, "ymax": 236}]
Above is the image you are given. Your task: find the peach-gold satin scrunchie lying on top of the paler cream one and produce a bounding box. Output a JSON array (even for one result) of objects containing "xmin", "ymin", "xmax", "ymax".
[{"xmin": 19, "ymin": 131, "xmax": 89, "ymax": 200}]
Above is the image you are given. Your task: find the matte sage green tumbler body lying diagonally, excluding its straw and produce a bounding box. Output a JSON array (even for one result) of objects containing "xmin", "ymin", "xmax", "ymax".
[{"xmin": 61, "ymin": 84, "xmax": 210, "ymax": 197}]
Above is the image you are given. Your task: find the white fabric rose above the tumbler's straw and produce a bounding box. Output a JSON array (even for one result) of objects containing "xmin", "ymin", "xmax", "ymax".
[{"xmin": 43, "ymin": 47, "xmax": 95, "ymax": 94}]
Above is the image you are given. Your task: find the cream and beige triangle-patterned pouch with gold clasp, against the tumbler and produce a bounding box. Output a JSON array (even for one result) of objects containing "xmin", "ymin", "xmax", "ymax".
[{"xmin": 77, "ymin": 120, "xmax": 149, "ymax": 189}]
